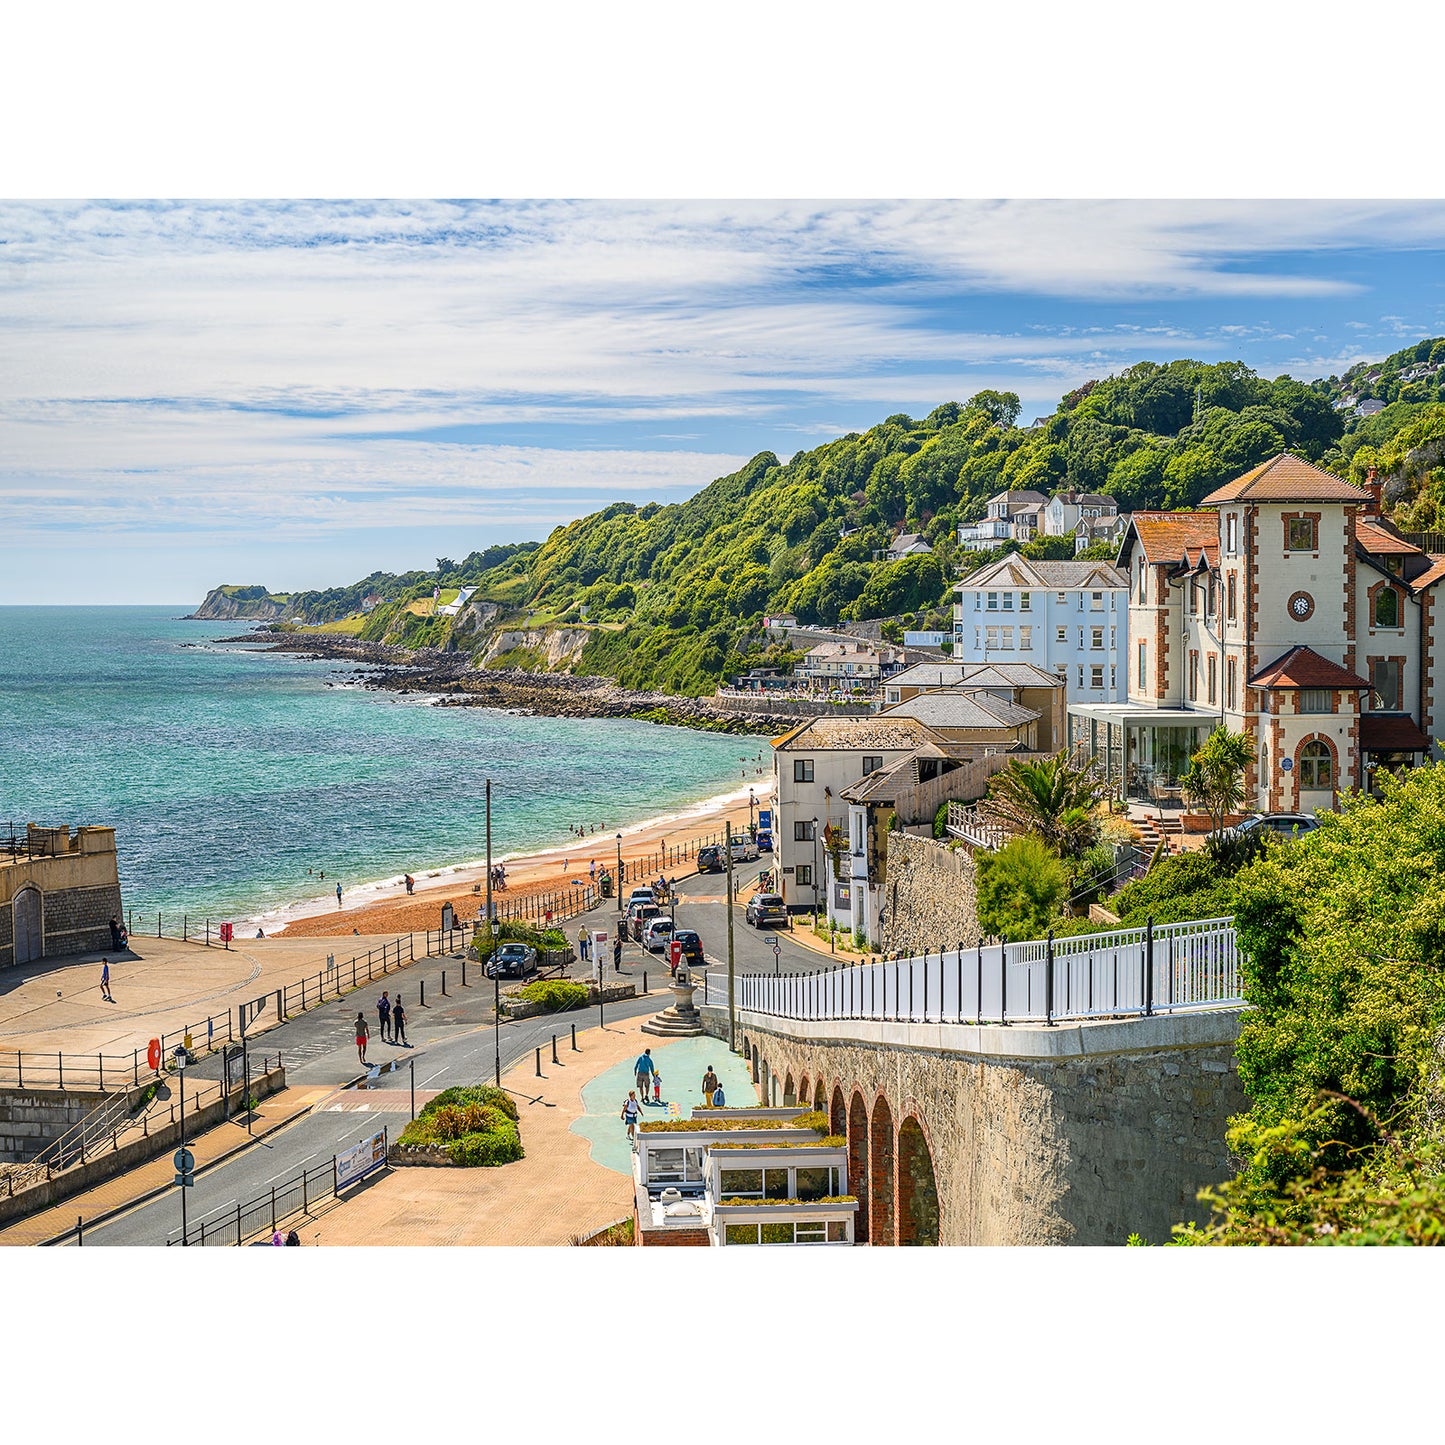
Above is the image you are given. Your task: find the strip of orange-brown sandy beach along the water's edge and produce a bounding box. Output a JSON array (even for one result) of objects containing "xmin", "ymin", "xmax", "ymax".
[{"xmin": 274, "ymin": 774, "xmax": 773, "ymax": 938}]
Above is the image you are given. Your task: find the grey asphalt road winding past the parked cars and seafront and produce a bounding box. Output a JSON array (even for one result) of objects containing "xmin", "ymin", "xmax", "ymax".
[{"xmin": 85, "ymin": 855, "xmax": 831, "ymax": 1246}]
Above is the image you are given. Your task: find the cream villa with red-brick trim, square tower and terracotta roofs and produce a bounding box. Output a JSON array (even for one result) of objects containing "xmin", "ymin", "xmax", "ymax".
[{"xmin": 1068, "ymin": 452, "xmax": 1445, "ymax": 812}]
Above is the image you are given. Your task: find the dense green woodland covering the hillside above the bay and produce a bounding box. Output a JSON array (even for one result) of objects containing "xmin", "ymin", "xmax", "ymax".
[{"xmin": 268, "ymin": 338, "xmax": 1445, "ymax": 694}]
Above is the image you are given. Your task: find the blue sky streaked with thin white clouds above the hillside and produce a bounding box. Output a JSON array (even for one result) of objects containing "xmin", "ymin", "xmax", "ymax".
[{"xmin": 0, "ymin": 201, "xmax": 1445, "ymax": 603}]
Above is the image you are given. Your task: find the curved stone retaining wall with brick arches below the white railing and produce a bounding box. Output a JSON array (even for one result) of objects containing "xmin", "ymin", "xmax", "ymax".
[{"xmin": 704, "ymin": 1007, "xmax": 1248, "ymax": 1244}]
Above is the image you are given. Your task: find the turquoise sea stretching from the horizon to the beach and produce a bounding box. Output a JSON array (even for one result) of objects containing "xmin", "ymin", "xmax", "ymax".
[{"xmin": 0, "ymin": 607, "xmax": 759, "ymax": 919}]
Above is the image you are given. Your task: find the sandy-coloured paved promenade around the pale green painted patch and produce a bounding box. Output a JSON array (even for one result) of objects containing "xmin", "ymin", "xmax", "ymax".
[{"xmin": 308, "ymin": 1019, "xmax": 756, "ymax": 1244}]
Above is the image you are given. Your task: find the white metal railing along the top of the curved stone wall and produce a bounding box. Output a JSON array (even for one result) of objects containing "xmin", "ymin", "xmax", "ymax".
[{"xmin": 707, "ymin": 918, "xmax": 1244, "ymax": 1023}]
